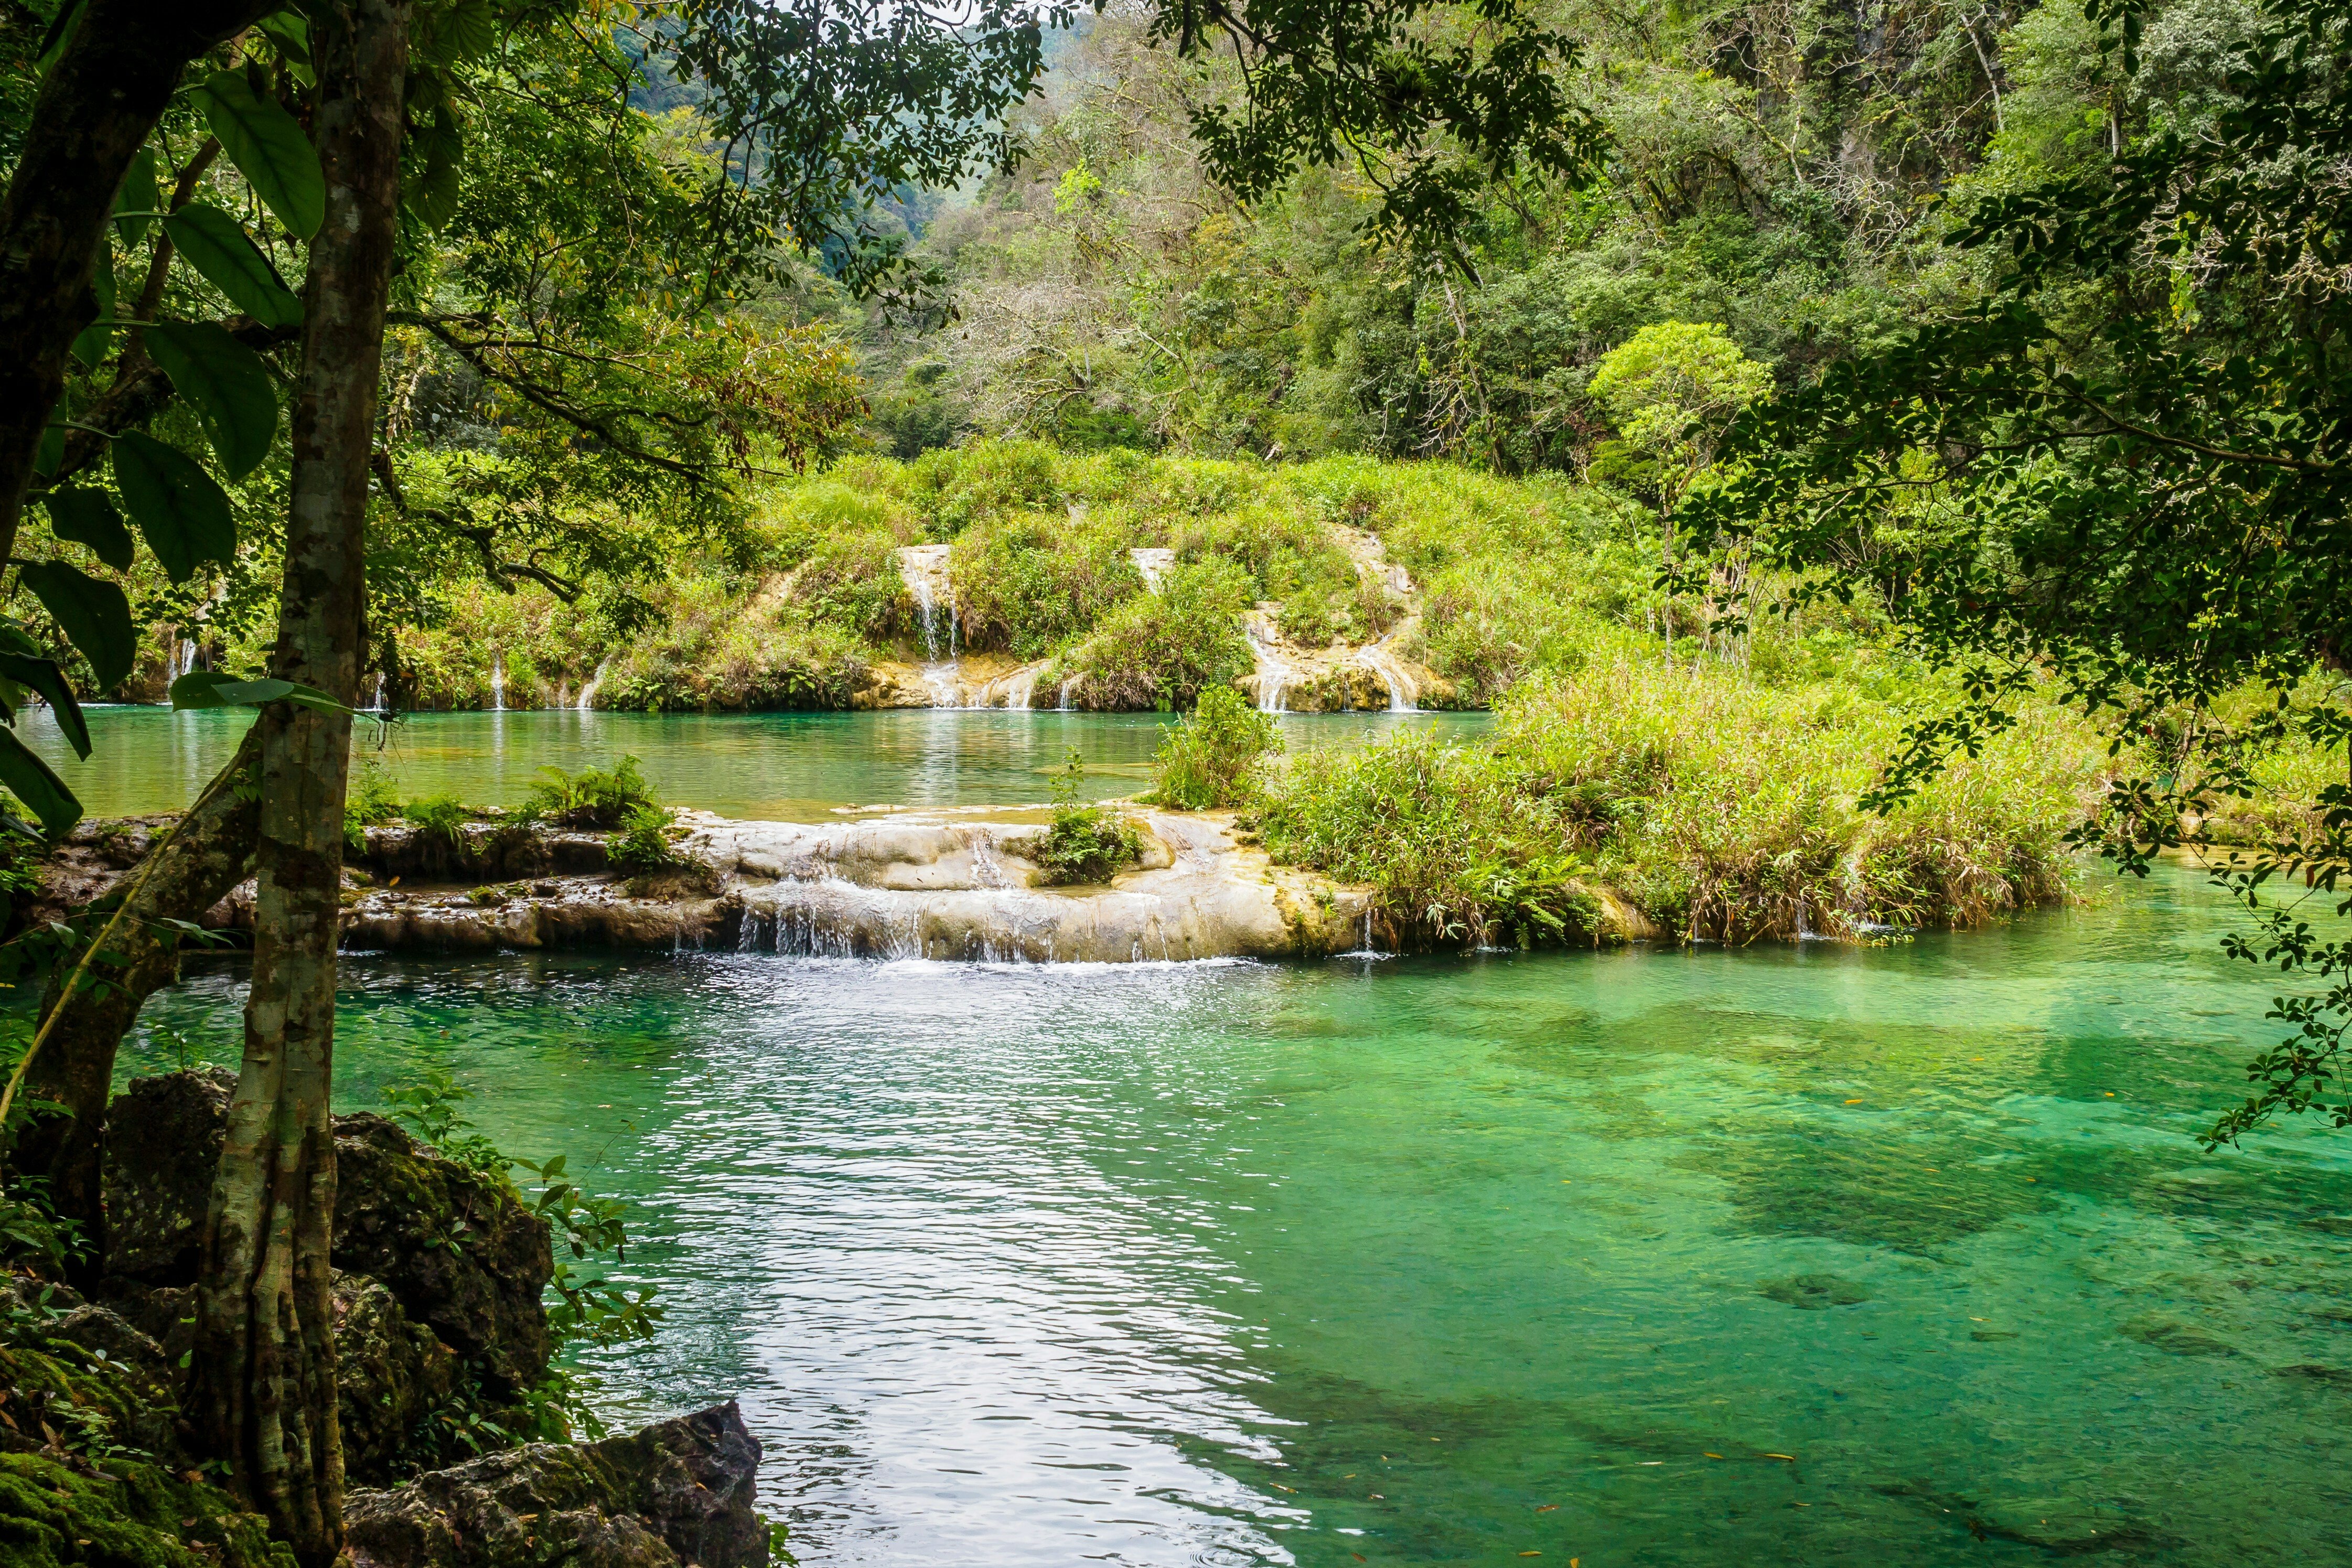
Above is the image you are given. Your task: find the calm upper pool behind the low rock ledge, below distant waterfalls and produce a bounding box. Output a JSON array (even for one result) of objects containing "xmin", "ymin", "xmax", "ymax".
[{"xmin": 21, "ymin": 707, "xmax": 1489, "ymax": 823}]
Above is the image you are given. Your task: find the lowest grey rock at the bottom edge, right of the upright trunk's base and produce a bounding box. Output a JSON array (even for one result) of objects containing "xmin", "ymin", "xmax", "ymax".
[{"xmin": 343, "ymin": 1401, "xmax": 769, "ymax": 1568}]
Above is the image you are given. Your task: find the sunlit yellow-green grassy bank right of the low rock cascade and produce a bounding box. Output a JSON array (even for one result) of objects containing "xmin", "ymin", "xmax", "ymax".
[{"xmin": 1256, "ymin": 639, "xmax": 2108, "ymax": 945}]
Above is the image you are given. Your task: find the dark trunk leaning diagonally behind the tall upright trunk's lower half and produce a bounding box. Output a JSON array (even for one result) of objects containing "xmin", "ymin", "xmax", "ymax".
[{"xmin": 9, "ymin": 734, "xmax": 261, "ymax": 1279}]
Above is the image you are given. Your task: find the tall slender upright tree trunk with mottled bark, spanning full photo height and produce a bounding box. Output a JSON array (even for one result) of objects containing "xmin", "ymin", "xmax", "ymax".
[{"xmin": 193, "ymin": 0, "xmax": 409, "ymax": 1568}]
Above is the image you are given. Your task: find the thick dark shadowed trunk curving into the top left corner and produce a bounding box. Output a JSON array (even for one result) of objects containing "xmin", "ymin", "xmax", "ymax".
[{"xmin": 0, "ymin": 0, "xmax": 280, "ymax": 560}]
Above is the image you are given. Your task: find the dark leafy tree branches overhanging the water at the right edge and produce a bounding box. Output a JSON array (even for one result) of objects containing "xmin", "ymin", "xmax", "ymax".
[{"xmin": 1693, "ymin": 0, "xmax": 2352, "ymax": 1143}]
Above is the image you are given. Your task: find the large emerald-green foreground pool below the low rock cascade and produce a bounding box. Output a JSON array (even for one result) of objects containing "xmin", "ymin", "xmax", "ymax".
[{"xmin": 134, "ymin": 875, "xmax": 2352, "ymax": 1568}]
